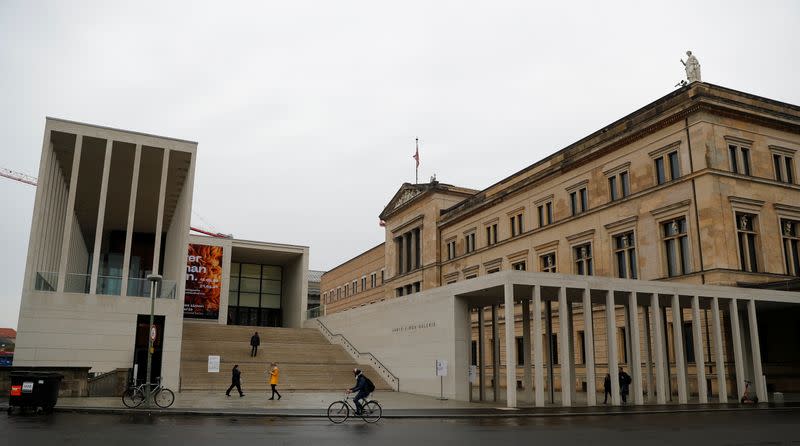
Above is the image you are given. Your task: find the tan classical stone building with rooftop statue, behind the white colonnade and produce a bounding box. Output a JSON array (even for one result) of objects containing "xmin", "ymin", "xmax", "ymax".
[{"xmin": 321, "ymin": 82, "xmax": 800, "ymax": 404}]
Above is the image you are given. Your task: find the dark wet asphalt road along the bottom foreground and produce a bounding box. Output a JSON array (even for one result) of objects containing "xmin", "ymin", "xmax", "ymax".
[{"xmin": 6, "ymin": 410, "xmax": 800, "ymax": 446}]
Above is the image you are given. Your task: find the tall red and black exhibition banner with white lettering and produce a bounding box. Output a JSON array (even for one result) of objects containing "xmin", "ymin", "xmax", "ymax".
[{"xmin": 183, "ymin": 244, "xmax": 222, "ymax": 319}]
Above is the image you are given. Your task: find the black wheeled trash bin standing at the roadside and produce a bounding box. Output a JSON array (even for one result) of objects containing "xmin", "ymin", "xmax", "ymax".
[{"xmin": 8, "ymin": 371, "xmax": 64, "ymax": 413}]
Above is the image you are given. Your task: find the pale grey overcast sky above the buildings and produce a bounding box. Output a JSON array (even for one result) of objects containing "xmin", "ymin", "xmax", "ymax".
[{"xmin": 0, "ymin": 0, "xmax": 800, "ymax": 327}]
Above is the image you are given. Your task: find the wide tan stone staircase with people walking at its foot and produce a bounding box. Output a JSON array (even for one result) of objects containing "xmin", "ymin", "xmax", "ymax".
[{"xmin": 180, "ymin": 322, "xmax": 392, "ymax": 395}]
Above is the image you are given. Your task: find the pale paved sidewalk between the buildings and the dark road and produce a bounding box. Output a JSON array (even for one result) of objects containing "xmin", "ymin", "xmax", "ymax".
[{"xmin": 6, "ymin": 391, "xmax": 800, "ymax": 418}]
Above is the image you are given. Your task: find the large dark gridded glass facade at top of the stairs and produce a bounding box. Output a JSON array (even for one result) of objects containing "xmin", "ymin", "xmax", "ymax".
[{"xmin": 228, "ymin": 262, "xmax": 283, "ymax": 327}]
